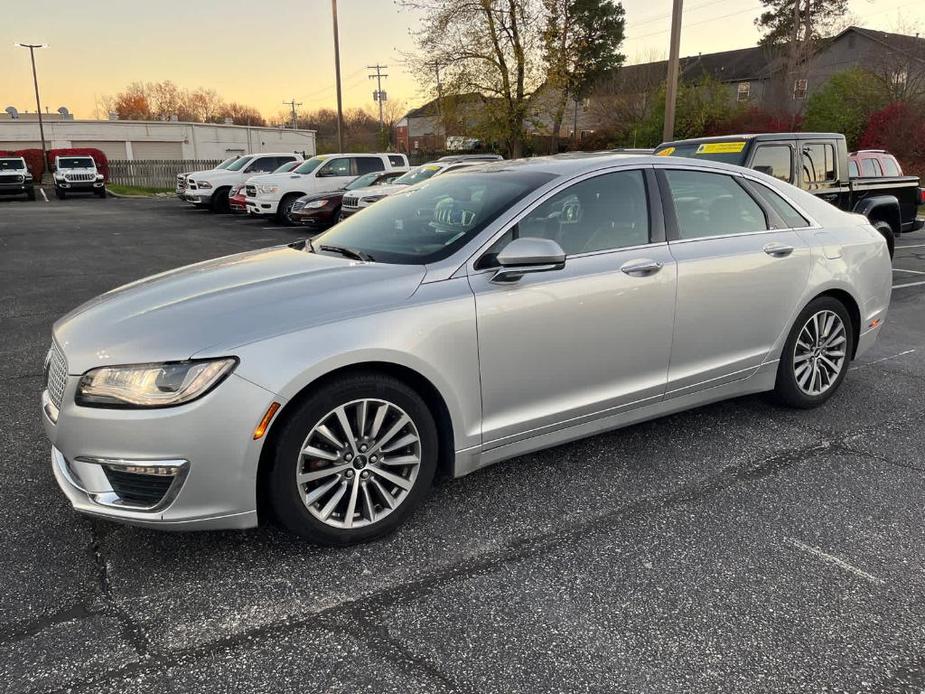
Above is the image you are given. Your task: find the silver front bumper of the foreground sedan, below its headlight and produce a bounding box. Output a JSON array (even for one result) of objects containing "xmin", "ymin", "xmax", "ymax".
[{"xmin": 42, "ymin": 374, "xmax": 282, "ymax": 530}]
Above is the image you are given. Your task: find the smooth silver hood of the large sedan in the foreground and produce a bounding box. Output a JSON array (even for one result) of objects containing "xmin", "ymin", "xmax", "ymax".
[{"xmin": 54, "ymin": 246, "xmax": 424, "ymax": 374}]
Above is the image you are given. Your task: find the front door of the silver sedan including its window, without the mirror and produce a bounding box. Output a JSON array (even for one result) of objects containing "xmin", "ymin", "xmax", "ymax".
[{"xmin": 470, "ymin": 170, "xmax": 675, "ymax": 448}]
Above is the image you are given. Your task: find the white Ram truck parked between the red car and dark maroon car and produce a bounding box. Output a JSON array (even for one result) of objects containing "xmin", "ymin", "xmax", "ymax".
[{"xmin": 245, "ymin": 154, "xmax": 408, "ymax": 224}]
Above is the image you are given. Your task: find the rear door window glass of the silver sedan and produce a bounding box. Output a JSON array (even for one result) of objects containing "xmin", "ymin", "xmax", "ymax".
[{"xmin": 665, "ymin": 170, "xmax": 768, "ymax": 240}]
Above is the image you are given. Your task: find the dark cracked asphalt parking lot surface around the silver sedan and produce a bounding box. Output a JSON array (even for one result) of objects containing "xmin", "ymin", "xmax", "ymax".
[{"xmin": 0, "ymin": 198, "xmax": 925, "ymax": 694}]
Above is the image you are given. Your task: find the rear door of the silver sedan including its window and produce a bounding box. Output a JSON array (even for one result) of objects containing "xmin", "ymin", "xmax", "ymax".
[{"xmin": 658, "ymin": 167, "xmax": 811, "ymax": 397}]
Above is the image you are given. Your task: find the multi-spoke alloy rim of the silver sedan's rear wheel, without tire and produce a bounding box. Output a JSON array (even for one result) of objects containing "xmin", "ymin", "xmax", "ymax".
[{"xmin": 793, "ymin": 310, "xmax": 848, "ymax": 396}]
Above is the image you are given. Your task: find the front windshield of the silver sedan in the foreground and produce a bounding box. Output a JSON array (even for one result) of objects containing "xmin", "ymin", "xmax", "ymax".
[{"xmin": 313, "ymin": 170, "xmax": 554, "ymax": 265}]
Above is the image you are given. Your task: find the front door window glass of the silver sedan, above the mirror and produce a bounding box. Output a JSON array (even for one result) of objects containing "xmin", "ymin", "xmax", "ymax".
[{"xmin": 512, "ymin": 171, "xmax": 649, "ymax": 255}]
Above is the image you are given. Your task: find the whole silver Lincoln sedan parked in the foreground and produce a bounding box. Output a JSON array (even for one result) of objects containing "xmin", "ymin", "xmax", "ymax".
[{"xmin": 42, "ymin": 154, "xmax": 891, "ymax": 544}]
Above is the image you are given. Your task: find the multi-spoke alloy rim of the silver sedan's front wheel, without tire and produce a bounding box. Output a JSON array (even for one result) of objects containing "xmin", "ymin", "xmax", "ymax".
[{"xmin": 295, "ymin": 399, "xmax": 421, "ymax": 529}]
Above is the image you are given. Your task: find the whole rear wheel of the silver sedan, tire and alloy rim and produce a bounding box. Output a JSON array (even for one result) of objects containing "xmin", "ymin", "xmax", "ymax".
[{"xmin": 774, "ymin": 296, "xmax": 854, "ymax": 409}]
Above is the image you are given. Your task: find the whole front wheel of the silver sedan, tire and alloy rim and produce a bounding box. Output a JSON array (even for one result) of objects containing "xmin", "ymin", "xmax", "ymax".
[{"xmin": 266, "ymin": 373, "xmax": 438, "ymax": 545}]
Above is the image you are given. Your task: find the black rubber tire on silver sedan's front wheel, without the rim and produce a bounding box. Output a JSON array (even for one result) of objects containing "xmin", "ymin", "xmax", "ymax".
[{"xmin": 265, "ymin": 372, "xmax": 439, "ymax": 545}]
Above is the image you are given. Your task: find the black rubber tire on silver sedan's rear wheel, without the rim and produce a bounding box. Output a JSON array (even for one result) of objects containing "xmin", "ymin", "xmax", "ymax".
[{"xmin": 774, "ymin": 296, "xmax": 854, "ymax": 409}]
